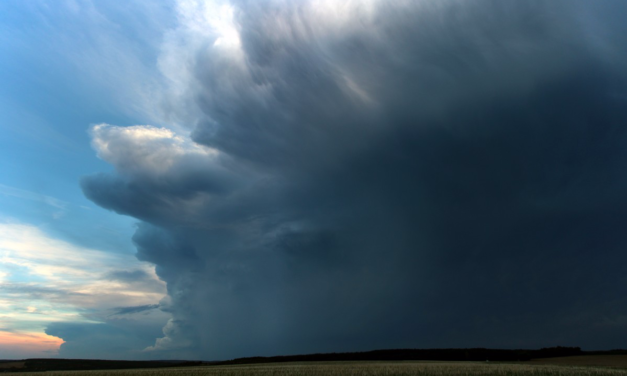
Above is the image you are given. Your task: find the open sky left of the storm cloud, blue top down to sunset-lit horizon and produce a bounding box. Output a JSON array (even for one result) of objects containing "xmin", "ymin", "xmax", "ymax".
[{"xmin": 0, "ymin": 1, "xmax": 172, "ymax": 358}]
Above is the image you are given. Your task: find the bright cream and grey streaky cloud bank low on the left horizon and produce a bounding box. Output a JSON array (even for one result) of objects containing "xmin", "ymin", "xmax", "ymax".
[{"xmin": 0, "ymin": 221, "xmax": 169, "ymax": 359}]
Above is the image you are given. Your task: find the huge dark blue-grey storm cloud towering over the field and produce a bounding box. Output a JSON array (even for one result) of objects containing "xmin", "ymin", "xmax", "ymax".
[{"xmin": 83, "ymin": 1, "xmax": 627, "ymax": 359}]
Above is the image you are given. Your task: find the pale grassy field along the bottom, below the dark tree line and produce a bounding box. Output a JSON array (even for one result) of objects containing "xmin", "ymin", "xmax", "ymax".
[{"xmin": 7, "ymin": 362, "xmax": 627, "ymax": 376}]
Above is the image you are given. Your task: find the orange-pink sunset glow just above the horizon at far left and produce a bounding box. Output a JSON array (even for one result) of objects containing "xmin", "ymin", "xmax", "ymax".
[{"xmin": 0, "ymin": 331, "xmax": 65, "ymax": 357}]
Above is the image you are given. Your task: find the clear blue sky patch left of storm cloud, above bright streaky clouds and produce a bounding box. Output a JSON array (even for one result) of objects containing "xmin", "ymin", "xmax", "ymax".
[{"xmin": 0, "ymin": 1, "xmax": 164, "ymax": 252}]
